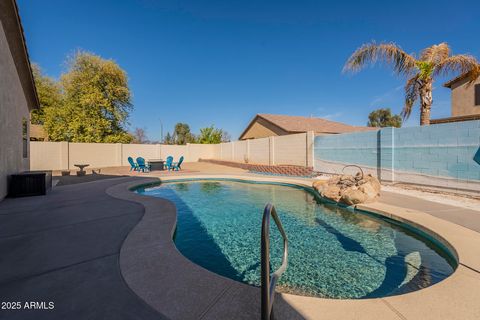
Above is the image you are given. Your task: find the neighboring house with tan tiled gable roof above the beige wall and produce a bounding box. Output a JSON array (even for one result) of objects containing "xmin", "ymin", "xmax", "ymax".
[{"xmin": 239, "ymin": 114, "xmax": 378, "ymax": 140}]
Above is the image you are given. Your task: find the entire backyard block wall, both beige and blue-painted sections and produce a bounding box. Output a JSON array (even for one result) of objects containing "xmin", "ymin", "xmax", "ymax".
[{"xmin": 30, "ymin": 121, "xmax": 480, "ymax": 192}]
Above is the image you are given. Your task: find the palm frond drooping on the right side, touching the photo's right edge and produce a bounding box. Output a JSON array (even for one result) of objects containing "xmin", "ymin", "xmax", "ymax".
[{"xmin": 433, "ymin": 54, "xmax": 480, "ymax": 83}]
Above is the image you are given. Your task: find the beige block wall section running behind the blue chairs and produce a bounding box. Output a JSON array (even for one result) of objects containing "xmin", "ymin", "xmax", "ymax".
[{"xmin": 30, "ymin": 132, "xmax": 314, "ymax": 170}]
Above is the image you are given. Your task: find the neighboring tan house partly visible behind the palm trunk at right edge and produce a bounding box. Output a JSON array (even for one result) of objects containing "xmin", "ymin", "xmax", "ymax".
[{"xmin": 430, "ymin": 73, "xmax": 480, "ymax": 124}]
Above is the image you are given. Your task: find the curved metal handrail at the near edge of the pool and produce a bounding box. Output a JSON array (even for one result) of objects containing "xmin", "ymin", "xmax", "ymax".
[{"xmin": 261, "ymin": 203, "xmax": 288, "ymax": 320}]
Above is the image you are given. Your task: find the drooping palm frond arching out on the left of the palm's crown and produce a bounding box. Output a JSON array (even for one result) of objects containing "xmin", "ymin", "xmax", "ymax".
[{"xmin": 343, "ymin": 42, "xmax": 416, "ymax": 75}]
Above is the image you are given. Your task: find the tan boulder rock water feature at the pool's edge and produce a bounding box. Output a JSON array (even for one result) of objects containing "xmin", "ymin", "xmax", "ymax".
[{"xmin": 313, "ymin": 171, "xmax": 381, "ymax": 205}]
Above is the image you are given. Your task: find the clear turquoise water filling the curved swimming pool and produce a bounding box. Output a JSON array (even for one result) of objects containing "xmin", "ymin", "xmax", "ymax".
[{"xmin": 137, "ymin": 180, "xmax": 456, "ymax": 299}]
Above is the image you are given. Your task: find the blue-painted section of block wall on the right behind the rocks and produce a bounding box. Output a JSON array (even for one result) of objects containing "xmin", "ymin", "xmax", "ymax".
[{"xmin": 315, "ymin": 121, "xmax": 480, "ymax": 190}]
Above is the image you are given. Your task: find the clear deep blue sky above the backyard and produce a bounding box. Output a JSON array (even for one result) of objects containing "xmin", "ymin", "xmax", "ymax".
[{"xmin": 17, "ymin": 0, "xmax": 480, "ymax": 139}]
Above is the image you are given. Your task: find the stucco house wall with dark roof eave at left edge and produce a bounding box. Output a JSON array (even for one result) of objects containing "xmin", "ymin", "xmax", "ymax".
[{"xmin": 0, "ymin": 0, "xmax": 39, "ymax": 200}]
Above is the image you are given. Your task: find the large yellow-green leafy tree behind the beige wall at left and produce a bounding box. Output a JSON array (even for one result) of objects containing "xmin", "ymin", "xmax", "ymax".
[{"xmin": 44, "ymin": 51, "xmax": 133, "ymax": 143}]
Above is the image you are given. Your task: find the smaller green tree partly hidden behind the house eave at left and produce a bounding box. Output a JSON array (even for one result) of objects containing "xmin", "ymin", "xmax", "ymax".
[{"xmin": 31, "ymin": 63, "xmax": 63, "ymax": 124}]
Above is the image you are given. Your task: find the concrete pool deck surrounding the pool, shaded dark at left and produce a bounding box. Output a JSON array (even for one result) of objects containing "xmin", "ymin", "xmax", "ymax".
[{"xmin": 0, "ymin": 166, "xmax": 480, "ymax": 319}]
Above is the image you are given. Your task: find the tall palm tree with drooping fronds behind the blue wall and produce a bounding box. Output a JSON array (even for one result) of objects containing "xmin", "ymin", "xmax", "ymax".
[{"xmin": 343, "ymin": 42, "xmax": 480, "ymax": 126}]
